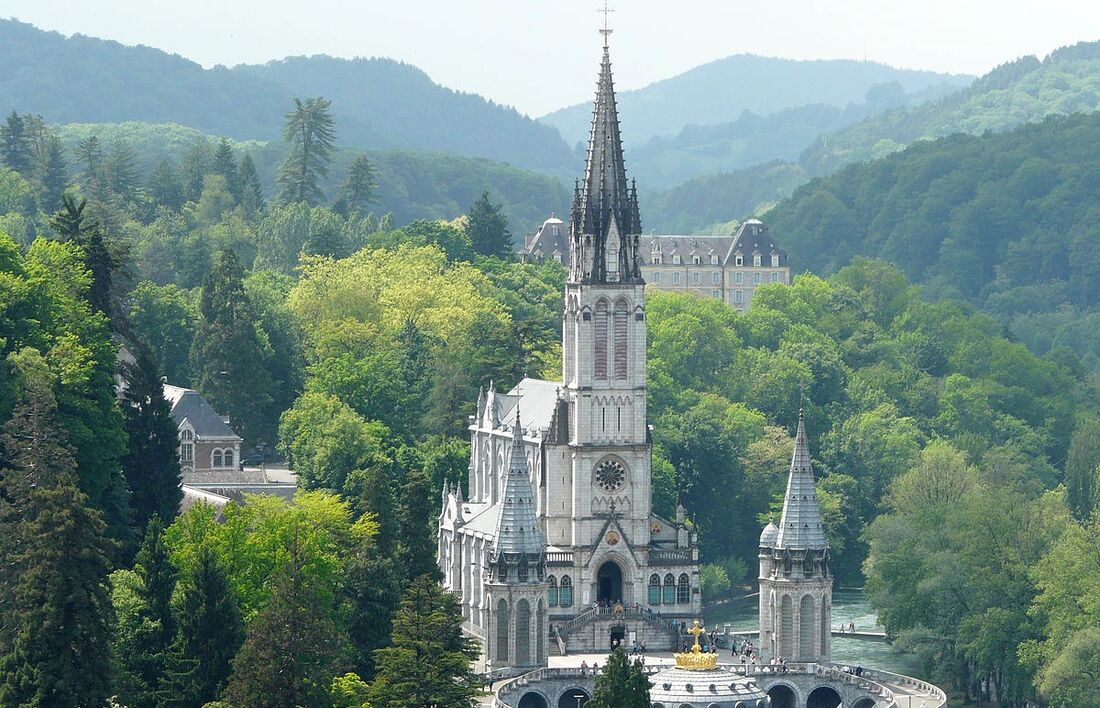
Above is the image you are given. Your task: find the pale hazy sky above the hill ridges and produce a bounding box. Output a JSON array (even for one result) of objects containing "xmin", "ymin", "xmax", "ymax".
[{"xmin": 0, "ymin": 0, "xmax": 1100, "ymax": 115}]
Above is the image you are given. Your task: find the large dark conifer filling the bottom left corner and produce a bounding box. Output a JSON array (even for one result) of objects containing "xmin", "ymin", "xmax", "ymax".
[{"xmin": 0, "ymin": 373, "xmax": 111, "ymax": 708}]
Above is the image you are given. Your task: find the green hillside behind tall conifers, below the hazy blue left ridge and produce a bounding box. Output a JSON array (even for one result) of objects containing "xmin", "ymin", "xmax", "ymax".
[{"xmin": 57, "ymin": 122, "xmax": 569, "ymax": 229}]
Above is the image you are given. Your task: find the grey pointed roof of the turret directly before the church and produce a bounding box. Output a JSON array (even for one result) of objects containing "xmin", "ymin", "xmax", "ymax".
[{"xmin": 493, "ymin": 408, "xmax": 547, "ymax": 558}]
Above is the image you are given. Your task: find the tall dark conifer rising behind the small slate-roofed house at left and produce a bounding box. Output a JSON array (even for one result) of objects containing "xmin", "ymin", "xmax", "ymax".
[{"xmin": 191, "ymin": 251, "xmax": 276, "ymax": 445}]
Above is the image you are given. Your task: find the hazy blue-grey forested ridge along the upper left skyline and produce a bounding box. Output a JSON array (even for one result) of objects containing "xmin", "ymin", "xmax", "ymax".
[{"xmin": 0, "ymin": 20, "xmax": 574, "ymax": 174}]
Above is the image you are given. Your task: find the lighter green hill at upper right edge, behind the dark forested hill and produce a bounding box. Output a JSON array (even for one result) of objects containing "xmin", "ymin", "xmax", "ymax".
[{"xmin": 801, "ymin": 42, "xmax": 1100, "ymax": 175}]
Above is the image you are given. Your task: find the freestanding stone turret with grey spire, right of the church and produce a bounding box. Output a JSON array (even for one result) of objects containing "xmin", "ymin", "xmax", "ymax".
[{"xmin": 759, "ymin": 409, "xmax": 833, "ymax": 662}]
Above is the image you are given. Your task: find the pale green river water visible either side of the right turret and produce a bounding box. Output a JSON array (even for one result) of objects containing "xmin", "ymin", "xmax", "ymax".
[{"xmin": 703, "ymin": 590, "xmax": 920, "ymax": 676}]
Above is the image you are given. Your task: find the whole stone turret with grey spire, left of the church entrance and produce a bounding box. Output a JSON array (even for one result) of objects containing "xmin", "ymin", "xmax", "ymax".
[{"xmin": 485, "ymin": 407, "xmax": 549, "ymax": 667}]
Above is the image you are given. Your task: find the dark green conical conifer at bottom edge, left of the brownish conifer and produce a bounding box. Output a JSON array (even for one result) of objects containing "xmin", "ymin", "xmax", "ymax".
[{"xmin": 157, "ymin": 546, "xmax": 244, "ymax": 708}]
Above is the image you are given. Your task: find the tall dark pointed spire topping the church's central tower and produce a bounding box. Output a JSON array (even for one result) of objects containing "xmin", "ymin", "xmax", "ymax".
[{"xmin": 570, "ymin": 29, "xmax": 641, "ymax": 283}]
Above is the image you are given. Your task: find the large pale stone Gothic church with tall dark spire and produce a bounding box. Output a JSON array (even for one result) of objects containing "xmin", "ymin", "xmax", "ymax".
[{"xmin": 438, "ymin": 35, "xmax": 701, "ymax": 671}]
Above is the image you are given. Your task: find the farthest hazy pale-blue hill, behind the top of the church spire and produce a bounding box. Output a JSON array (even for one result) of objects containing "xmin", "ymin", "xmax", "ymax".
[{"xmin": 539, "ymin": 54, "xmax": 974, "ymax": 145}]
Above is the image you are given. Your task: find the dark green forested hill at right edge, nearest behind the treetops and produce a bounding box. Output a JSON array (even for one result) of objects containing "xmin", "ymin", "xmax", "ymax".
[{"xmin": 768, "ymin": 113, "xmax": 1100, "ymax": 369}]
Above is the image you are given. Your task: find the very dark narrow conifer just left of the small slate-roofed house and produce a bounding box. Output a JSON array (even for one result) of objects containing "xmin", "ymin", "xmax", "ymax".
[{"xmin": 122, "ymin": 346, "xmax": 183, "ymax": 530}]
